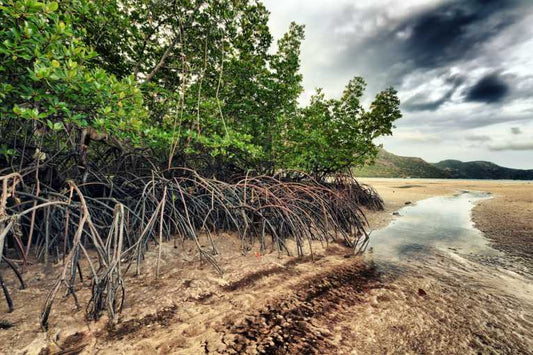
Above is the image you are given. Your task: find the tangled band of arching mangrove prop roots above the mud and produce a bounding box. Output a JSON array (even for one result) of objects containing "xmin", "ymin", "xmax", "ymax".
[{"xmin": 0, "ymin": 168, "xmax": 383, "ymax": 328}]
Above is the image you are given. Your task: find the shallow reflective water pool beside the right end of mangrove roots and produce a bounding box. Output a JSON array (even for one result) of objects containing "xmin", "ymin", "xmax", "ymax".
[{"xmin": 369, "ymin": 191, "xmax": 499, "ymax": 260}]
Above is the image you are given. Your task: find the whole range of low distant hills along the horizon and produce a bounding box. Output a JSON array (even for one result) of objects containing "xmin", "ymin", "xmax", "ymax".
[{"xmin": 354, "ymin": 149, "xmax": 533, "ymax": 180}]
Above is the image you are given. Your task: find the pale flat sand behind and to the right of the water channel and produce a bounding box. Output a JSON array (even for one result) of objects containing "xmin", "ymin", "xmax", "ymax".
[{"xmin": 361, "ymin": 178, "xmax": 533, "ymax": 270}]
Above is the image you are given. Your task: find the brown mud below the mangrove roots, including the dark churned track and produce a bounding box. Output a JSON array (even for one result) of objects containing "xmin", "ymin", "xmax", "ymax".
[{"xmin": 0, "ymin": 235, "xmax": 379, "ymax": 354}]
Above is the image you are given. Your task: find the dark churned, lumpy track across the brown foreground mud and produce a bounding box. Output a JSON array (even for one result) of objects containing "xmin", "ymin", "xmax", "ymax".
[{"xmin": 225, "ymin": 263, "xmax": 382, "ymax": 354}]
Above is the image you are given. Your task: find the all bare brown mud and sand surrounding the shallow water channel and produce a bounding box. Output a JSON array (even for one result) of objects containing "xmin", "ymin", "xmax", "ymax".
[{"xmin": 0, "ymin": 179, "xmax": 533, "ymax": 354}]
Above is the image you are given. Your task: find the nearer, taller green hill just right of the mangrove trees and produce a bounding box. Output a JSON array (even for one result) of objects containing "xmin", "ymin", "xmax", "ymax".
[{"xmin": 354, "ymin": 149, "xmax": 450, "ymax": 178}]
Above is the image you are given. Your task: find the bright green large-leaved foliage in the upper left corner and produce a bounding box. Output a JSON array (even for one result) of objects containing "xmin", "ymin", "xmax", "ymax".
[{"xmin": 0, "ymin": 1, "xmax": 145, "ymax": 144}]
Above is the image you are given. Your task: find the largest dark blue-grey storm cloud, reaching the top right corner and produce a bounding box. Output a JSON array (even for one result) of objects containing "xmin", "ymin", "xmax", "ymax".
[{"xmin": 334, "ymin": 0, "xmax": 533, "ymax": 96}]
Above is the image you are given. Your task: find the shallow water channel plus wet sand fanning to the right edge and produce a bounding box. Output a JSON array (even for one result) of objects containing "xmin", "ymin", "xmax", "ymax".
[{"xmin": 367, "ymin": 191, "xmax": 533, "ymax": 306}]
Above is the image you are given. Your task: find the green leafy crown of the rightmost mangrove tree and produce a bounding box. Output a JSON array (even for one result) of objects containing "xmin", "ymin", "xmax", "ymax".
[{"xmin": 282, "ymin": 77, "xmax": 401, "ymax": 176}]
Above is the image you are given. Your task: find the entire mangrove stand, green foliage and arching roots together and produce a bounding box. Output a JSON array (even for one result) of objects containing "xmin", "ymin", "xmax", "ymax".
[{"xmin": 0, "ymin": 0, "xmax": 401, "ymax": 327}]
